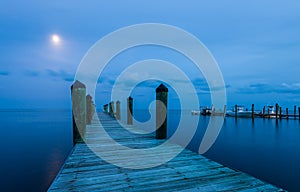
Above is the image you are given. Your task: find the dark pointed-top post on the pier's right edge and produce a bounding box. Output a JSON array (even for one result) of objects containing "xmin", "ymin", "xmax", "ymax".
[{"xmin": 156, "ymin": 84, "xmax": 168, "ymax": 139}]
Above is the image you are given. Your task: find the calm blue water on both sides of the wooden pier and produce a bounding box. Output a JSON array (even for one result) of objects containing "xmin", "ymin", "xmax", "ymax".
[{"xmin": 0, "ymin": 110, "xmax": 300, "ymax": 191}]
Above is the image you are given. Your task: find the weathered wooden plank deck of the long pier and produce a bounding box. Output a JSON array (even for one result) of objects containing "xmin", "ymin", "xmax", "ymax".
[{"xmin": 49, "ymin": 114, "xmax": 283, "ymax": 192}]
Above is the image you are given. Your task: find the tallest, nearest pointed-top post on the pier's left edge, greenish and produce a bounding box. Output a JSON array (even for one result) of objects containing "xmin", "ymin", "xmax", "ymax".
[{"xmin": 71, "ymin": 80, "xmax": 86, "ymax": 145}]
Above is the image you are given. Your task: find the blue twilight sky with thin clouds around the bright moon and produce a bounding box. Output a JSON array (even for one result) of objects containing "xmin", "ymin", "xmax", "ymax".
[{"xmin": 0, "ymin": 0, "xmax": 300, "ymax": 108}]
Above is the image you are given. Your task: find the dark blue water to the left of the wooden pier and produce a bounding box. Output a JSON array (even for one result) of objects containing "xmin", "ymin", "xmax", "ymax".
[{"xmin": 0, "ymin": 110, "xmax": 72, "ymax": 191}]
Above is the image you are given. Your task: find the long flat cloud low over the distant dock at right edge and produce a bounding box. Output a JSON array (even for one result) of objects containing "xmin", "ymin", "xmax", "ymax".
[{"xmin": 236, "ymin": 83, "xmax": 300, "ymax": 94}]
